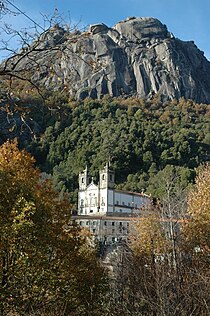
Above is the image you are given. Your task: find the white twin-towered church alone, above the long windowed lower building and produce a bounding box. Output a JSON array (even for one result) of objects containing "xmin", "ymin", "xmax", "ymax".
[{"xmin": 78, "ymin": 164, "xmax": 151, "ymax": 216}]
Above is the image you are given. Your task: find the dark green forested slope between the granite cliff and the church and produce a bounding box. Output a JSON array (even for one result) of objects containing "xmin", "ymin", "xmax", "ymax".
[{"xmin": 0, "ymin": 92, "xmax": 210, "ymax": 202}]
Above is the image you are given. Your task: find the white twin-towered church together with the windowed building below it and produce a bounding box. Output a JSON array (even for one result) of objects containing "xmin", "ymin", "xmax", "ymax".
[{"xmin": 73, "ymin": 164, "xmax": 151, "ymax": 244}]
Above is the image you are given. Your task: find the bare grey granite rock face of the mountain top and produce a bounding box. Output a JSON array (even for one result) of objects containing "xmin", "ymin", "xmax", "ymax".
[{"xmin": 9, "ymin": 17, "xmax": 210, "ymax": 103}]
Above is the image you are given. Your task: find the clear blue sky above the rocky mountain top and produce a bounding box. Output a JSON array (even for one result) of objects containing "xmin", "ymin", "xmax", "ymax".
[{"xmin": 0, "ymin": 0, "xmax": 210, "ymax": 60}]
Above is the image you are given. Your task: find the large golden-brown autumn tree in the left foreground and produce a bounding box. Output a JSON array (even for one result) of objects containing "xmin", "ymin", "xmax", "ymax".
[{"xmin": 0, "ymin": 142, "xmax": 103, "ymax": 315}]
